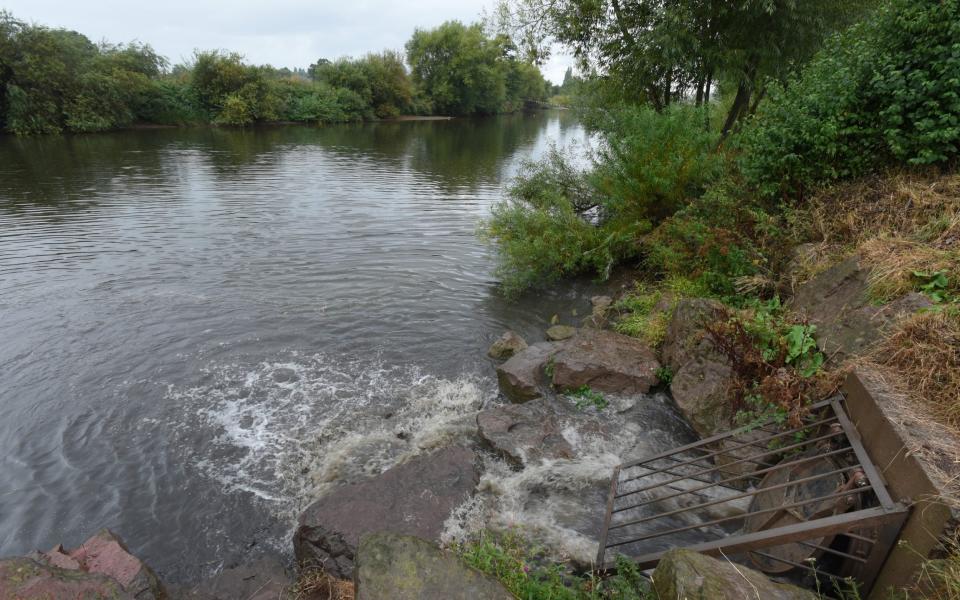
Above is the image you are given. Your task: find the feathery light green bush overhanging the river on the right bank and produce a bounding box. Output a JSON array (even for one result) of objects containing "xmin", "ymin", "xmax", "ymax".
[{"xmin": 485, "ymin": 107, "xmax": 723, "ymax": 295}]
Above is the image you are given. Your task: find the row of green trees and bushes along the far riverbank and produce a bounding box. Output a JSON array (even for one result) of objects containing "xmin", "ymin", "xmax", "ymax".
[{"xmin": 0, "ymin": 11, "xmax": 552, "ymax": 135}]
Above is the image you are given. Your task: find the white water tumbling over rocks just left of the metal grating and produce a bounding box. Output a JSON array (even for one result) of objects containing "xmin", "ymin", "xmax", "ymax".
[{"xmin": 443, "ymin": 394, "xmax": 693, "ymax": 566}]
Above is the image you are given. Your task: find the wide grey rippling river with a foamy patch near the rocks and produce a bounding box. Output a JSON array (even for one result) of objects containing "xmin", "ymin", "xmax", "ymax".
[{"xmin": 0, "ymin": 113, "xmax": 692, "ymax": 580}]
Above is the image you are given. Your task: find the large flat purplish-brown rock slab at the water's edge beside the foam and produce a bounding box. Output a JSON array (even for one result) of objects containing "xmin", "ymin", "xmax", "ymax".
[{"xmin": 293, "ymin": 447, "xmax": 479, "ymax": 579}]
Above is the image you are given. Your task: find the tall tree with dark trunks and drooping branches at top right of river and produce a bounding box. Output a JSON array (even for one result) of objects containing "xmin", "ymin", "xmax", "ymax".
[{"xmin": 492, "ymin": 0, "xmax": 873, "ymax": 133}]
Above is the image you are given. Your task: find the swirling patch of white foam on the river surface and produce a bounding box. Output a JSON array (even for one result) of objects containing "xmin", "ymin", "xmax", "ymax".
[{"xmin": 167, "ymin": 352, "xmax": 496, "ymax": 521}]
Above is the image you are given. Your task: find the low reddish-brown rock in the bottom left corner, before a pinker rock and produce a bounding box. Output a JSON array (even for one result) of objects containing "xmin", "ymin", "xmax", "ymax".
[{"xmin": 0, "ymin": 557, "xmax": 137, "ymax": 600}]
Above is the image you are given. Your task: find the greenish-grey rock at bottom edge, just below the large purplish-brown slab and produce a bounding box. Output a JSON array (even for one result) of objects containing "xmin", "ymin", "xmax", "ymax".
[{"xmin": 355, "ymin": 533, "xmax": 514, "ymax": 600}]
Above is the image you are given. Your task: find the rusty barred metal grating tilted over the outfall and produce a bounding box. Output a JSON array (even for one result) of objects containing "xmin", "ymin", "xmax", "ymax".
[{"xmin": 597, "ymin": 396, "xmax": 908, "ymax": 592}]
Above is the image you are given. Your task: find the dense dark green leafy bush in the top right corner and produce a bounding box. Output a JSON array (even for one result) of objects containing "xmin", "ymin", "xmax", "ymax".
[{"xmin": 741, "ymin": 0, "xmax": 960, "ymax": 199}]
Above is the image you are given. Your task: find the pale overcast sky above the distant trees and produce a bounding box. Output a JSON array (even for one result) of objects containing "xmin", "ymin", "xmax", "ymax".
[{"xmin": 0, "ymin": 0, "xmax": 573, "ymax": 83}]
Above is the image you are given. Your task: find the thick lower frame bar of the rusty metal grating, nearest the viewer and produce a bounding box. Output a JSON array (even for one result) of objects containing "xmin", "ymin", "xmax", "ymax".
[{"xmin": 612, "ymin": 503, "xmax": 908, "ymax": 570}]
